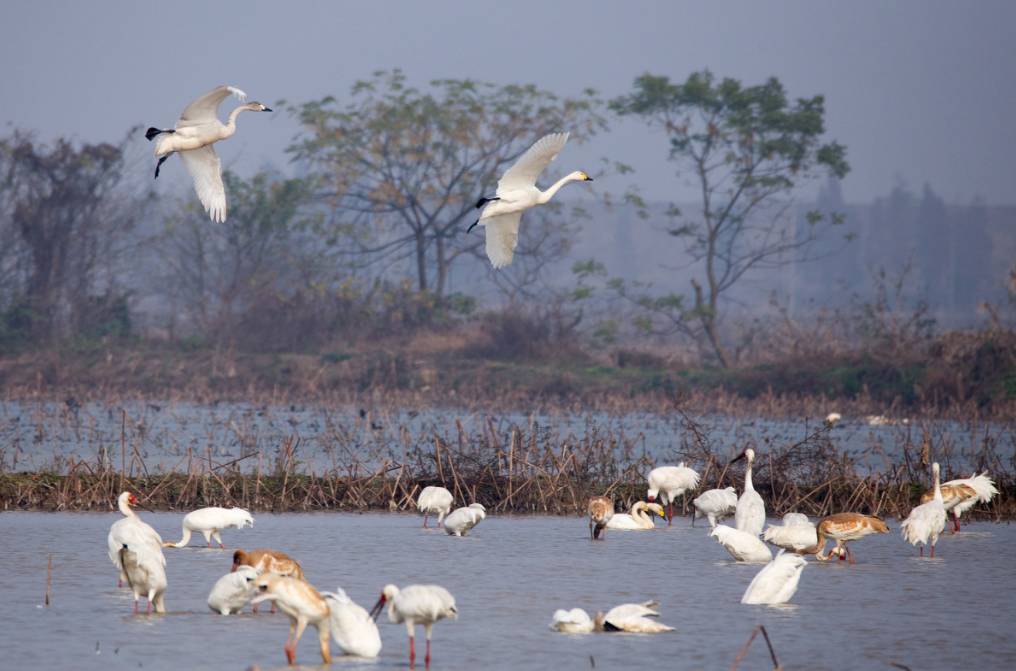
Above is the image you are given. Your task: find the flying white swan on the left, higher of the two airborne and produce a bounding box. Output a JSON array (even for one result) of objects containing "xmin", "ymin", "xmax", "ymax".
[{"xmin": 144, "ymin": 85, "xmax": 271, "ymax": 223}]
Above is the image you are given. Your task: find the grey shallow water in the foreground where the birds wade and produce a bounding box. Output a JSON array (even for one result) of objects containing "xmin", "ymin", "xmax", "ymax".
[{"xmin": 0, "ymin": 512, "xmax": 1016, "ymax": 671}]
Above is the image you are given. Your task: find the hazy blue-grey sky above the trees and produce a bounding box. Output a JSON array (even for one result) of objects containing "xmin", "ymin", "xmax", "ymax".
[{"xmin": 0, "ymin": 0, "xmax": 1016, "ymax": 203}]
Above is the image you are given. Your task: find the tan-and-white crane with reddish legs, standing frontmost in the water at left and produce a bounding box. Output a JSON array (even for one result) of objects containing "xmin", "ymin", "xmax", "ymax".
[{"xmin": 251, "ymin": 573, "xmax": 331, "ymax": 666}]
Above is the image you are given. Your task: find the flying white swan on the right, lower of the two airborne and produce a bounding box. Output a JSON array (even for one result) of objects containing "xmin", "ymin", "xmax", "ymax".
[{"xmin": 466, "ymin": 133, "xmax": 592, "ymax": 268}]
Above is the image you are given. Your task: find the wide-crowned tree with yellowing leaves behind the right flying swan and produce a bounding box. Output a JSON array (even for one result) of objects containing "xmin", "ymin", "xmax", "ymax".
[{"xmin": 291, "ymin": 70, "xmax": 606, "ymax": 297}]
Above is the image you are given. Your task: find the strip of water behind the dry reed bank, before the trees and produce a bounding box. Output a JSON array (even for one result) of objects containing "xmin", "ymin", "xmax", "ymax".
[{"xmin": 0, "ymin": 401, "xmax": 1003, "ymax": 477}]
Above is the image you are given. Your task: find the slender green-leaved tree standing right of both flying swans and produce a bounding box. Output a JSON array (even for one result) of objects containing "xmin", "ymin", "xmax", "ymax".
[{"xmin": 611, "ymin": 71, "xmax": 849, "ymax": 367}]
